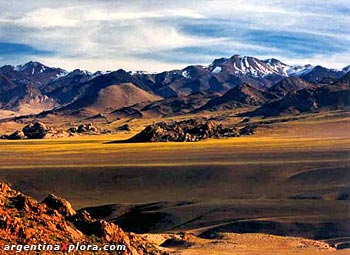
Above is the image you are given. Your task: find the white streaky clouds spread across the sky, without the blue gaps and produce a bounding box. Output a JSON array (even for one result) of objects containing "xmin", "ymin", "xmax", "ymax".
[{"xmin": 0, "ymin": 0, "xmax": 350, "ymax": 71}]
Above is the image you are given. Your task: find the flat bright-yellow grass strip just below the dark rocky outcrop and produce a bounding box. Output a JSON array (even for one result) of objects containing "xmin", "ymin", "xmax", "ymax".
[{"xmin": 0, "ymin": 135, "xmax": 350, "ymax": 169}]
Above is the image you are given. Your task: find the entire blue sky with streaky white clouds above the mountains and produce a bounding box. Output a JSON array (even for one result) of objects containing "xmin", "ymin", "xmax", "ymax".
[{"xmin": 0, "ymin": 0, "xmax": 350, "ymax": 72}]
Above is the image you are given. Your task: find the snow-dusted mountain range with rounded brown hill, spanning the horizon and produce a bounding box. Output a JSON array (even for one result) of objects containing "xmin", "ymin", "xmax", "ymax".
[{"xmin": 0, "ymin": 55, "xmax": 350, "ymax": 118}]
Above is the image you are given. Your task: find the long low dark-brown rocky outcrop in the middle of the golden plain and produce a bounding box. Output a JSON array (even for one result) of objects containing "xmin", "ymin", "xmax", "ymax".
[{"xmin": 127, "ymin": 119, "xmax": 239, "ymax": 143}]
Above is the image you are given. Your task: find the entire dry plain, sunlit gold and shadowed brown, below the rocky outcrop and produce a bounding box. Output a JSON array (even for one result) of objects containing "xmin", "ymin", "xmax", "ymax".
[{"xmin": 0, "ymin": 112, "xmax": 350, "ymax": 255}]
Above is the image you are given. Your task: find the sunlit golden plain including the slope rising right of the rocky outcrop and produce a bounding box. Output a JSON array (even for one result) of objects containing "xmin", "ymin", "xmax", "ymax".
[{"xmin": 0, "ymin": 112, "xmax": 350, "ymax": 168}]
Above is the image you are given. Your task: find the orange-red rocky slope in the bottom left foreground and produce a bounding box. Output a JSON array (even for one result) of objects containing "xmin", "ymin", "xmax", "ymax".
[{"xmin": 0, "ymin": 181, "xmax": 166, "ymax": 255}]
